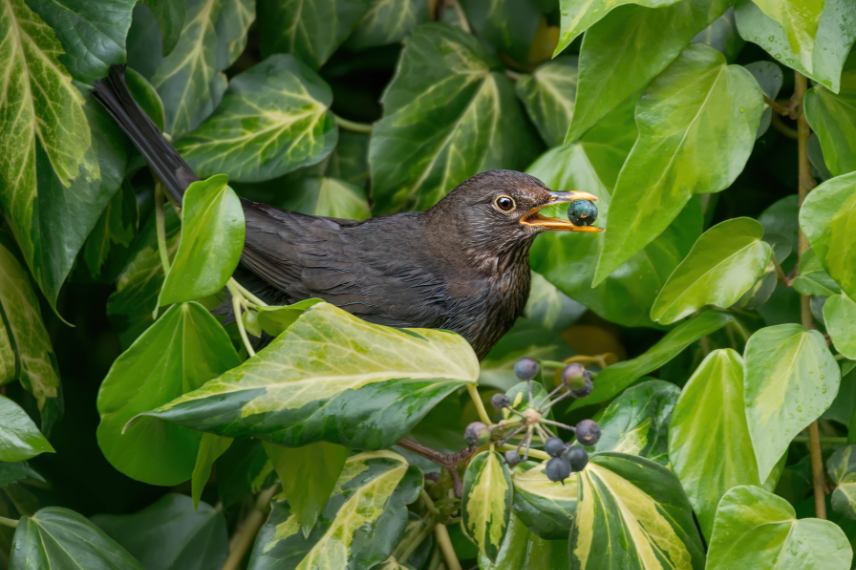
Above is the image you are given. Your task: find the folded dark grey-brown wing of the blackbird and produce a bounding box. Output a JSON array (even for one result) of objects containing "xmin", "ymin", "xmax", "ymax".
[{"xmin": 242, "ymin": 204, "xmax": 446, "ymax": 326}]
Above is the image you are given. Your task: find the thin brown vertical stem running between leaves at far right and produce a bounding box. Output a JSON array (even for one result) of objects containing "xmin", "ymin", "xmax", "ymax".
[{"xmin": 794, "ymin": 72, "xmax": 826, "ymax": 519}]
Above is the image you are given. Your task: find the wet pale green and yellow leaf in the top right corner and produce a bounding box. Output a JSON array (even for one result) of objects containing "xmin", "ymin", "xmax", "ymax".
[{"xmin": 736, "ymin": 0, "xmax": 856, "ymax": 93}]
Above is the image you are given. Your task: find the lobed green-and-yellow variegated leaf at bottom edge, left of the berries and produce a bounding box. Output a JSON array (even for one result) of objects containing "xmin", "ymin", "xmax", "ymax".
[{"xmin": 248, "ymin": 451, "xmax": 422, "ymax": 570}]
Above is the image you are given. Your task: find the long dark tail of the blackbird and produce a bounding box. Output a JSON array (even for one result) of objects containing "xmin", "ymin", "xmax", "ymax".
[{"xmin": 95, "ymin": 66, "xmax": 197, "ymax": 204}]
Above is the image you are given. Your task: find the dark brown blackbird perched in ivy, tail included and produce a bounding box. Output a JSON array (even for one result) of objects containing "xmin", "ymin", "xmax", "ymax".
[{"xmin": 94, "ymin": 66, "xmax": 600, "ymax": 359}]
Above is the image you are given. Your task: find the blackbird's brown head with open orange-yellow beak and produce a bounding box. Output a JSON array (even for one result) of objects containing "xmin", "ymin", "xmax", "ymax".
[{"xmin": 427, "ymin": 170, "xmax": 602, "ymax": 260}]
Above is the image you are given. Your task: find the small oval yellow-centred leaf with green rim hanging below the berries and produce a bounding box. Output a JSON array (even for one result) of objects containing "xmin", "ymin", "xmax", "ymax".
[{"xmin": 461, "ymin": 451, "xmax": 514, "ymax": 560}]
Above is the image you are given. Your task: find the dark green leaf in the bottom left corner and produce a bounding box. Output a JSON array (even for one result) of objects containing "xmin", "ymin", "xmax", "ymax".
[{"xmin": 9, "ymin": 507, "xmax": 142, "ymax": 570}]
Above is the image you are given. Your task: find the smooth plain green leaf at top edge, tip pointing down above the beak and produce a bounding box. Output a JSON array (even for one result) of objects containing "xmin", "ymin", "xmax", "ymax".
[{"xmin": 565, "ymin": 0, "xmax": 731, "ymax": 142}]
